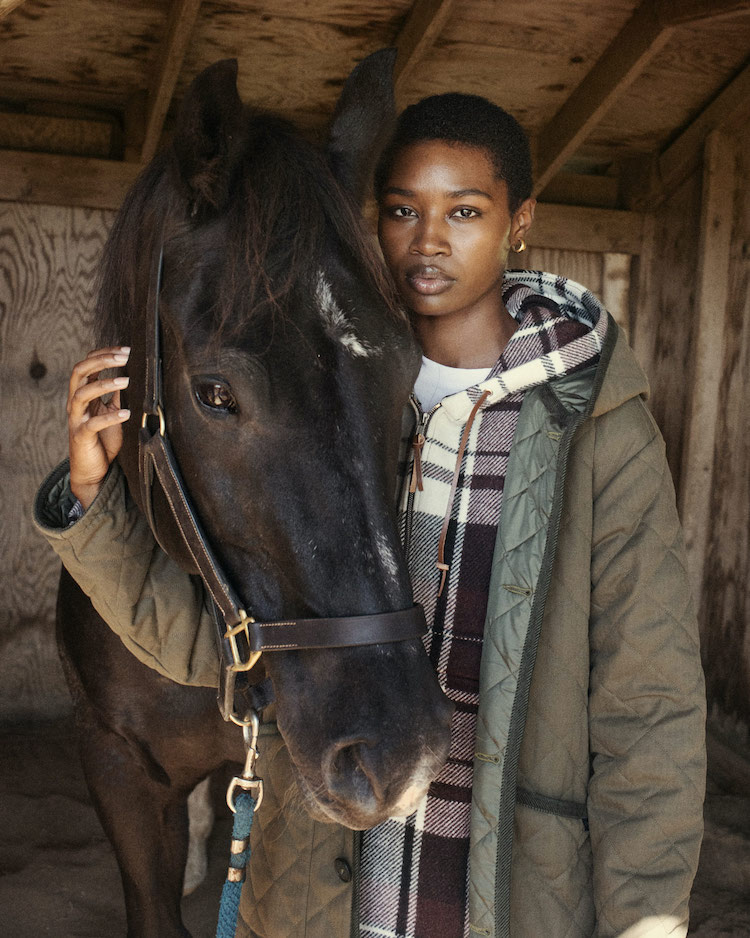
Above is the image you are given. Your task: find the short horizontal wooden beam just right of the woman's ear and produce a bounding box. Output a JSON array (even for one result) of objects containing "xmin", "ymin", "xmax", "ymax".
[{"xmin": 527, "ymin": 202, "xmax": 643, "ymax": 254}]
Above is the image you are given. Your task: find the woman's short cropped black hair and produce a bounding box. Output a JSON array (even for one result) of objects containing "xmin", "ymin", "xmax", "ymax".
[{"xmin": 375, "ymin": 92, "xmax": 532, "ymax": 212}]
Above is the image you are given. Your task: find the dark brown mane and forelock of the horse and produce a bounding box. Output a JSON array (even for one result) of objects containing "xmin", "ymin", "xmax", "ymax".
[{"xmin": 96, "ymin": 111, "xmax": 405, "ymax": 345}]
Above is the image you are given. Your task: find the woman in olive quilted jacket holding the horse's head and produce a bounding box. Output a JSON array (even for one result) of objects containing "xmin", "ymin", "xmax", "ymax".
[{"xmin": 36, "ymin": 94, "xmax": 705, "ymax": 938}]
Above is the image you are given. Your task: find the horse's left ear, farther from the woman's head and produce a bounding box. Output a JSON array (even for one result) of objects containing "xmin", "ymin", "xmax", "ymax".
[{"xmin": 172, "ymin": 59, "xmax": 245, "ymax": 215}]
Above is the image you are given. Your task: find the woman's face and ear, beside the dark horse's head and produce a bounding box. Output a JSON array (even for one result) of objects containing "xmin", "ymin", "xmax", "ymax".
[{"xmin": 378, "ymin": 140, "xmax": 533, "ymax": 317}]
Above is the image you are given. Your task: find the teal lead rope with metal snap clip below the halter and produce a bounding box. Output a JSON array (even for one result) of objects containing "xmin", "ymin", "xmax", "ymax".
[{"xmin": 216, "ymin": 711, "xmax": 263, "ymax": 938}]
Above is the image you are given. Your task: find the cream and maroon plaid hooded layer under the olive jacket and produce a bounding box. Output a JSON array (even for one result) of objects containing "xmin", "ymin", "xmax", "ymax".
[{"xmin": 360, "ymin": 271, "xmax": 607, "ymax": 938}]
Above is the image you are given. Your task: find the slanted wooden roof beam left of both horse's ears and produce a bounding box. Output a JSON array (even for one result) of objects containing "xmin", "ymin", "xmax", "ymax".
[{"xmin": 140, "ymin": 0, "xmax": 201, "ymax": 163}]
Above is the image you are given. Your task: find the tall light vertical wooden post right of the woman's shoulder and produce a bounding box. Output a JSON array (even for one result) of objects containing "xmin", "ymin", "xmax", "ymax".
[{"xmin": 680, "ymin": 130, "xmax": 736, "ymax": 595}]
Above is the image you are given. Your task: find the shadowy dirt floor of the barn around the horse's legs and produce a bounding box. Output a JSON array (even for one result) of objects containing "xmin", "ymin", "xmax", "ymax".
[{"xmin": 0, "ymin": 721, "xmax": 750, "ymax": 938}]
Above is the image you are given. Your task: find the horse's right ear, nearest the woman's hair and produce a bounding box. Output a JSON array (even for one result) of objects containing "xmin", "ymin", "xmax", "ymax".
[{"xmin": 328, "ymin": 49, "xmax": 396, "ymax": 202}]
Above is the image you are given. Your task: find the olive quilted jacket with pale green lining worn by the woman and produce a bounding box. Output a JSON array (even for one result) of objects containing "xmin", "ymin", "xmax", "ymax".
[{"xmin": 35, "ymin": 321, "xmax": 705, "ymax": 938}]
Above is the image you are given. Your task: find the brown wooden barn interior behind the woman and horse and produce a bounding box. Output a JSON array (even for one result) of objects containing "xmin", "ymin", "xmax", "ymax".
[{"xmin": 0, "ymin": 0, "xmax": 750, "ymax": 938}]
